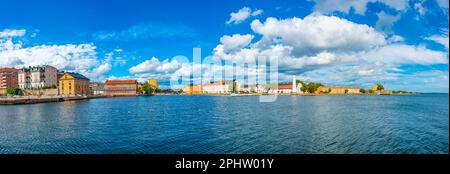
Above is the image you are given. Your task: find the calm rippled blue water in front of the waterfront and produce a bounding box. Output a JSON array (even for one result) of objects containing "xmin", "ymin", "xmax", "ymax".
[{"xmin": 0, "ymin": 94, "xmax": 449, "ymax": 154}]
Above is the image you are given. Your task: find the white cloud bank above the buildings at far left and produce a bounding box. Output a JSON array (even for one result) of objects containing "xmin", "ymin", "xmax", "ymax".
[{"xmin": 0, "ymin": 29, "xmax": 111, "ymax": 81}]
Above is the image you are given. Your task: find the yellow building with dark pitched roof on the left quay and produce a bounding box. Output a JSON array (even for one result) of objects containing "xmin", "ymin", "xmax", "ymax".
[{"xmin": 59, "ymin": 73, "xmax": 90, "ymax": 95}]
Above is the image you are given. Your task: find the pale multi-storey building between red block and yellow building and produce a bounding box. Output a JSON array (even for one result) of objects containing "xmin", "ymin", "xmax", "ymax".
[{"xmin": 18, "ymin": 65, "xmax": 58, "ymax": 89}]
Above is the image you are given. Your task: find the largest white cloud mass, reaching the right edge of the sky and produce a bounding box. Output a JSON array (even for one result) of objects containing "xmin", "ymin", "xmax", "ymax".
[{"xmin": 213, "ymin": 14, "xmax": 448, "ymax": 87}]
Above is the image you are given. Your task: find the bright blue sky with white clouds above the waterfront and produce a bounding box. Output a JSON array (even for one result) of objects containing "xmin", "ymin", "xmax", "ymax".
[{"xmin": 0, "ymin": 0, "xmax": 449, "ymax": 93}]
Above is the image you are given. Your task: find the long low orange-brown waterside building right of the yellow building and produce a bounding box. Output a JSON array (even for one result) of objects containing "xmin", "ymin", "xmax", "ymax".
[{"xmin": 104, "ymin": 80, "xmax": 139, "ymax": 96}]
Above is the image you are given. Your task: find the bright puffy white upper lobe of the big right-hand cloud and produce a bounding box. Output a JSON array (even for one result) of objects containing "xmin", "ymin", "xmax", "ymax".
[{"xmin": 251, "ymin": 15, "xmax": 385, "ymax": 55}]
